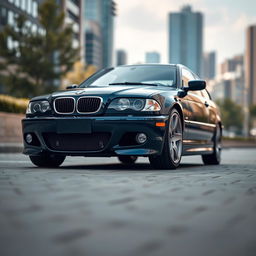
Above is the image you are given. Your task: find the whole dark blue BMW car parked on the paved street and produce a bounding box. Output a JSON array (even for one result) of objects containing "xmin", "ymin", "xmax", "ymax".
[{"xmin": 22, "ymin": 64, "xmax": 222, "ymax": 169}]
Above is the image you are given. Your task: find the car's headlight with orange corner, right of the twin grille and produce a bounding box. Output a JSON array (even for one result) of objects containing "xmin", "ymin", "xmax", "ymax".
[{"xmin": 108, "ymin": 98, "xmax": 161, "ymax": 111}]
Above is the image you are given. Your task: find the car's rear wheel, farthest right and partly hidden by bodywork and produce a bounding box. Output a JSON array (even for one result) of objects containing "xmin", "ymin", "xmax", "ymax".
[{"xmin": 202, "ymin": 125, "xmax": 221, "ymax": 165}]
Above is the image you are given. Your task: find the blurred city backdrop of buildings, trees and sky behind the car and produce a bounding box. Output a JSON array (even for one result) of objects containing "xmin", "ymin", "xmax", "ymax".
[{"xmin": 0, "ymin": 0, "xmax": 256, "ymax": 142}]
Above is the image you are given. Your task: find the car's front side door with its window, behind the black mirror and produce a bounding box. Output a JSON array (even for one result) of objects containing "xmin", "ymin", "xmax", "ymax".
[{"xmin": 179, "ymin": 68, "xmax": 211, "ymax": 145}]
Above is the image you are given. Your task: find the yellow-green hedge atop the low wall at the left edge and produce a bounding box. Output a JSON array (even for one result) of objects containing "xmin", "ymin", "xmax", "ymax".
[{"xmin": 0, "ymin": 95, "xmax": 29, "ymax": 114}]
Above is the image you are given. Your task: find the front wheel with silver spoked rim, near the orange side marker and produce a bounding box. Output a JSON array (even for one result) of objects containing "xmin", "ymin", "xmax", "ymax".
[{"xmin": 149, "ymin": 109, "xmax": 183, "ymax": 169}]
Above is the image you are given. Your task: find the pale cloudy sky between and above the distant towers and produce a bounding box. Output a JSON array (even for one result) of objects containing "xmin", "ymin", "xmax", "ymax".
[{"xmin": 115, "ymin": 0, "xmax": 256, "ymax": 68}]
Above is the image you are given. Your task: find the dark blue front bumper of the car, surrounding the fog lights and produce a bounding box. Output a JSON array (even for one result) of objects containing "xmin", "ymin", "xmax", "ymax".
[{"xmin": 22, "ymin": 115, "xmax": 168, "ymax": 156}]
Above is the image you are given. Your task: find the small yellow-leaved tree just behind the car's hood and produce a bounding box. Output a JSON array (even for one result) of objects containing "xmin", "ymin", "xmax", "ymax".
[{"xmin": 65, "ymin": 61, "xmax": 96, "ymax": 85}]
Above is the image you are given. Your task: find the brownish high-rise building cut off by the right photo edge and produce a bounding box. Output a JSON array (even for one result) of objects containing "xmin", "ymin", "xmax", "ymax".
[{"xmin": 245, "ymin": 25, "xmax": 256, "ymax": 105}]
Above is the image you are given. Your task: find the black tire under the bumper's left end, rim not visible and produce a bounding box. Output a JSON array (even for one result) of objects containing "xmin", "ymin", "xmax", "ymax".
[{"xmin": 29, "ymin": 154, "xmax": 66, "ymax": 168}]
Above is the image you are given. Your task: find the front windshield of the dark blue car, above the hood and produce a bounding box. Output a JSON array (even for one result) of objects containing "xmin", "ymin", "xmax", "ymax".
[{"xmin": 79, "ymin": 65, "xmax": 176, "ymax": 87}]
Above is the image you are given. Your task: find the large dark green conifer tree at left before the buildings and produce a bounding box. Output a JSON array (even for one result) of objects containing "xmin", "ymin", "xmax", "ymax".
[{"xmin": 0, "ymin": 0, "xmax": 79, "ymax": 97}]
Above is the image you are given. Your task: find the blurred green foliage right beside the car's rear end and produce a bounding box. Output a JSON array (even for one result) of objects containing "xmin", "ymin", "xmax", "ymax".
[{"xmin": 217, "ymin": 99, "xmax": 243, "ymax": 131}]
